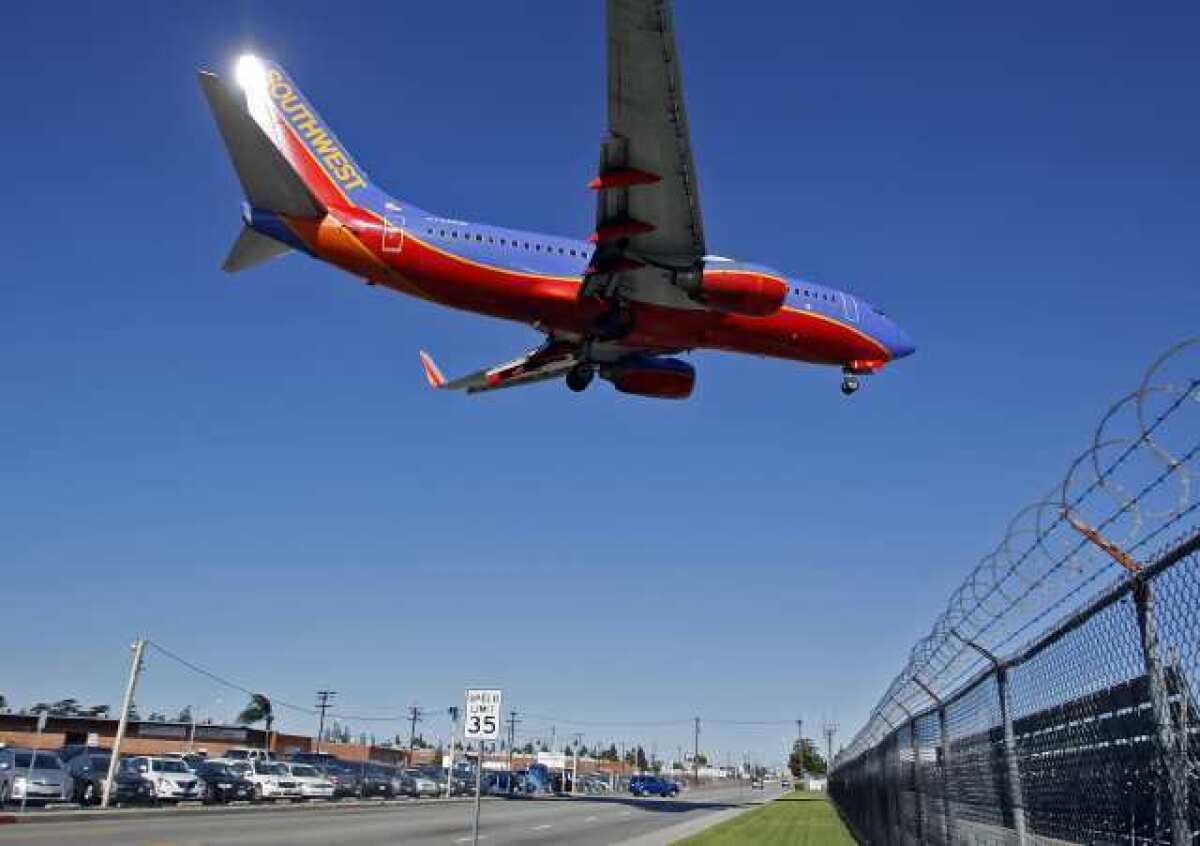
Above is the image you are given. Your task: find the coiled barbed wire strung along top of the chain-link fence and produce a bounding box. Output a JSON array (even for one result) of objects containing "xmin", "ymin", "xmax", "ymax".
[{"xmin": 839, "ymin": 337, "xmax": 1200, "ymax": 762}]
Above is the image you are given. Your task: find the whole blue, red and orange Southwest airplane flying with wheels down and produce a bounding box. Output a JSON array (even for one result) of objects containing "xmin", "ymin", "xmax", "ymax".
[{"xmin": 200, "ymin": 0, "xmax": 914, "ymax": 398}]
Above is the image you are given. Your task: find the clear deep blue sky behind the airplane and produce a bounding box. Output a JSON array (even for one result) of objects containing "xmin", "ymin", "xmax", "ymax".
[{"xmin": 0, "ymin": 0, "xmax": 1200, "ymax": 756}]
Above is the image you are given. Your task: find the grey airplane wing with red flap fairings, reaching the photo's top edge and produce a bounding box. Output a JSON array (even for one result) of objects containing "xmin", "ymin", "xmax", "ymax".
[{"xmin": 582, "ymin": 0, "xmax": 706, "ymax": 300}]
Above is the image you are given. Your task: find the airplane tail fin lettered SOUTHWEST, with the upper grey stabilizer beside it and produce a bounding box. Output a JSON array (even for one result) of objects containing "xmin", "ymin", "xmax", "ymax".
[{"xmin": 200, "ymin": 55, "xmax": 373, "ymax": 216}]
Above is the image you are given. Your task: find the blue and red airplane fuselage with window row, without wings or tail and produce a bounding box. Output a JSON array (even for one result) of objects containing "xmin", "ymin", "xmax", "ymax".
[{"xmin": 246, "ymin": 196, "xmax": 913, "ymax": 372}]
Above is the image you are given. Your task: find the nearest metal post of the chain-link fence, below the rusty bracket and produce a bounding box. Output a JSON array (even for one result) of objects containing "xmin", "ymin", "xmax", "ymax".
[{"xmin": 1133, "ymin": 577, "xmax": 1192, "ymax": 846}]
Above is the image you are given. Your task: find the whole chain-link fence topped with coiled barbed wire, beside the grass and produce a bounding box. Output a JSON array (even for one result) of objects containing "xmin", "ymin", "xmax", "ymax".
[{"xmin": 830, "ymin": 340, "xmax": 1200, "ymax": 846}]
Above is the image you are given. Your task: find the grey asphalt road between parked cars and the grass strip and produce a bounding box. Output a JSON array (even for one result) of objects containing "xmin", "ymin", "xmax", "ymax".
[{"xmin": 0, "ymin": 787, "xmax": 779, "ymax": 846}]
